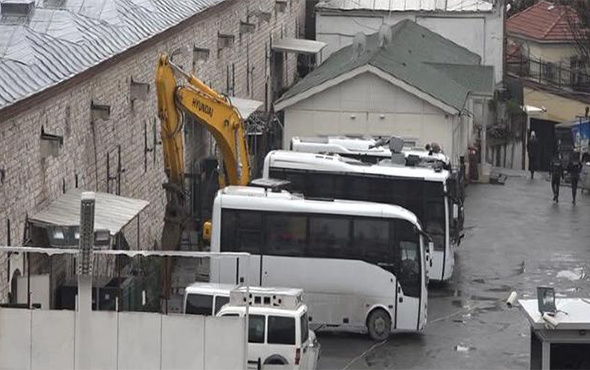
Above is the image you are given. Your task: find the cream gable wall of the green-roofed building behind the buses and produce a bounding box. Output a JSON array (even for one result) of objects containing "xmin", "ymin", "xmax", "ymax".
[{"xmin": 283, "ymin": 73, "xmax": 469, "ymax": 162}]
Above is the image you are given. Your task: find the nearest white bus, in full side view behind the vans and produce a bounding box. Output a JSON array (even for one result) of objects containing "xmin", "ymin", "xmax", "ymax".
[{"xmin": 210, "ymin": 186, "xmax": 428, "ymax": 340}]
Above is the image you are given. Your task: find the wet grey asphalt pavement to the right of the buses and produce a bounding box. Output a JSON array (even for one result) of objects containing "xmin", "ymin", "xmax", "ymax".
[{"xmin": 318, "ymin": 171, "xmax": 590, "ymax": 369}]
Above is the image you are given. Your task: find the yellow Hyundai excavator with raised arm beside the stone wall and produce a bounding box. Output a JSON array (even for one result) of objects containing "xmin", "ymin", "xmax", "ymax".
[{"xmin": 156, "ymin": 53, "xmax": 250, "ymax": 299}]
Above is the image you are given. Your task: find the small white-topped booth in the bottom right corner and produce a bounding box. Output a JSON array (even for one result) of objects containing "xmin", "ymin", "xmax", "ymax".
[{"xmin": 518, "ymin": 298, "xmax": 590, "ymax": 370}]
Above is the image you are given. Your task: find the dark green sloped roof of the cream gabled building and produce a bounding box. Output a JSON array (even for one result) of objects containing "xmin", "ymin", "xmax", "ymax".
[{"xmin": 275, "ymin": 20, "xmax": 494, "ymax": 110}]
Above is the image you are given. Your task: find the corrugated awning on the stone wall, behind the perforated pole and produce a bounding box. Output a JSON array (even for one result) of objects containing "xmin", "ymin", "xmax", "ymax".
[{"xmin": 29, "ymin": 189, "xmax": 149, "ymax": 236}]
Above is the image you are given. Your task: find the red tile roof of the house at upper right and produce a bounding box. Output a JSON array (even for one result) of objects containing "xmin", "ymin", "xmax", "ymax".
[{"xmin": 506, "ymin": 1, "xmax": 575, "ymax": 42}]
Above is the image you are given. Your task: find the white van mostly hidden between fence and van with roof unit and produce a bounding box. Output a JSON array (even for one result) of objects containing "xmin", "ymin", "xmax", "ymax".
[{"xmin": 183, "ymin": 283, "xmax": 236, "ymax": 316}]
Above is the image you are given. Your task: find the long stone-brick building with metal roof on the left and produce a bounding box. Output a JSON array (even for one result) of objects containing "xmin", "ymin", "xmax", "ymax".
[{"xmin": 0, "ymin": 0, "xmax": 305, "ymax": 302}]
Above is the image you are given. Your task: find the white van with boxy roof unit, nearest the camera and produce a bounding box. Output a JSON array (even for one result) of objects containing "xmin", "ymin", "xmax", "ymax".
[{"xmin": 217, "ymin": 287, "xmax": 320, "ymax": 369}]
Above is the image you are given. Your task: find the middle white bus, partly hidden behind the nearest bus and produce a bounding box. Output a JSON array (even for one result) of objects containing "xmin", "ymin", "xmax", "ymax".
[{"xmin": 263, "ymin": 150, "xmax": 461, "ymax": 281}]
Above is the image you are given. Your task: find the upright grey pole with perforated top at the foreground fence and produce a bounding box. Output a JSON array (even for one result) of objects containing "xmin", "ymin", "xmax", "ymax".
[{"xmin": 75, "ymin": 192, "xmax": 95, "ymax": 370}]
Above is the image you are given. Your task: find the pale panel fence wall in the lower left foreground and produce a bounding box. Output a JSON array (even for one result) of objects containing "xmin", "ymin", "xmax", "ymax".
[{"xmin": 0, "ymin": 309, "xmax": 245, "ymax": 370}]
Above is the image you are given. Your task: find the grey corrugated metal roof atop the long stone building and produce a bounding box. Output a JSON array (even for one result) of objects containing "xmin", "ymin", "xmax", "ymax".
[{"xmin": 0, "ymin": 0, "xmax": 225, "ymax": 109}]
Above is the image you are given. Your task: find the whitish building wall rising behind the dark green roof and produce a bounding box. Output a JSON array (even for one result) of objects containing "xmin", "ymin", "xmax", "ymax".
[{"xmin": 316, "ymin": 7, "xmax": 503, "ymax": 83}]
